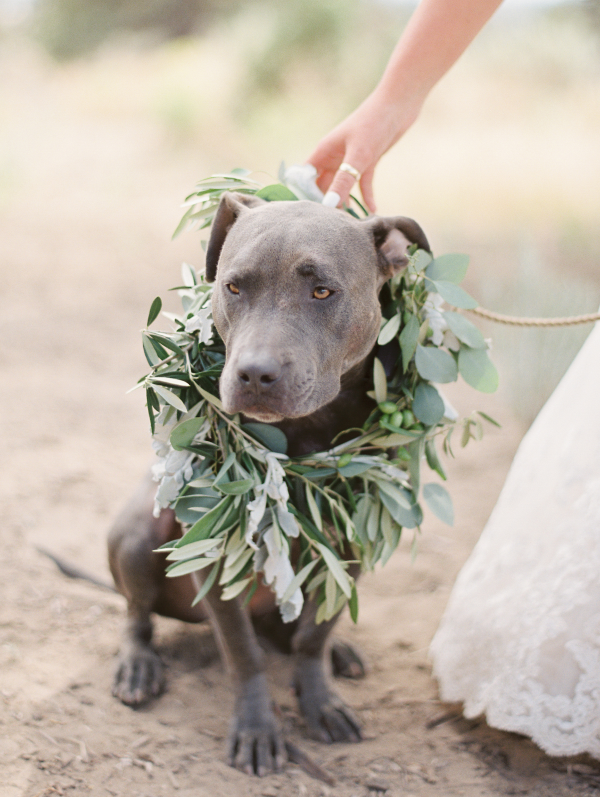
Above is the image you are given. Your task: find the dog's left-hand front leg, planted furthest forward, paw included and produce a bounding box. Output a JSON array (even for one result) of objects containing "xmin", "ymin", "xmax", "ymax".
[{"xmin": 192, "ymin": 571, "xmax": 286, "ymax": 775}]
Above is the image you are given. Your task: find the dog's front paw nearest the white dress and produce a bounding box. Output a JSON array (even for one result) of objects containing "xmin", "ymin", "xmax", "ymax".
[{"xmin": 294, "ymin": 660, "xmax": 362, "ymax": 744}]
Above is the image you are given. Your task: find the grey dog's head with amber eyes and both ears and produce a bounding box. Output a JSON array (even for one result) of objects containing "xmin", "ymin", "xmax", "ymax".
[{"xmin": 206, "ymin": 194, "xmax": 429, "ymax": 423}]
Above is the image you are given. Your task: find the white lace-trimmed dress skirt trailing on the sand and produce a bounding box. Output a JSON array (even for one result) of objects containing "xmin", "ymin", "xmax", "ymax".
[{"xmin": 431, "ymin": 324, "xmax": 600, "ymax": 758}]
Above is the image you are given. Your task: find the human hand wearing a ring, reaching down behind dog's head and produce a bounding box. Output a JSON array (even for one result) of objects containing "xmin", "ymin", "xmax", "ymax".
[{"xmin": 308, "ymin": 90, "xmax": 421, "ymax": 213}]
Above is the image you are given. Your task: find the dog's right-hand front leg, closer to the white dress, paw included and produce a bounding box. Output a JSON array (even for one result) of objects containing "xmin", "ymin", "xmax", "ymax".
[{"xmin": 292, "ymin": 565, "xmax": 362, "ymax": 743}]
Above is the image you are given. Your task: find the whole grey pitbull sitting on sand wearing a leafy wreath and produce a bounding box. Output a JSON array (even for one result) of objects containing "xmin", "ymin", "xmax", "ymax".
[{"xmin": 109, "ymin": 194, "xmax": 429, "ymax": 775}]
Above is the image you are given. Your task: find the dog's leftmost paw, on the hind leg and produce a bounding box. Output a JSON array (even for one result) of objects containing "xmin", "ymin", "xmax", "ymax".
[{"xmin": 112, "ymin": 645, "xmax": 165, "ymax": 707}]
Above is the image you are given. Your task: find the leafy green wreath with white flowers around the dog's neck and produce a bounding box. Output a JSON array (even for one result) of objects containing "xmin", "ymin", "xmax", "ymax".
[{"xmin": 137, "ymin": 167, "xmax": 498, "ymax": 622}]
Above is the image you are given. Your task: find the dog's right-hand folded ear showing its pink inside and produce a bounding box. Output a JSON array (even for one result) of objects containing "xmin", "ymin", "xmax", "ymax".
[{"xmin": 362, "ymin": 216, "xmax": 431, "ymax": 281}]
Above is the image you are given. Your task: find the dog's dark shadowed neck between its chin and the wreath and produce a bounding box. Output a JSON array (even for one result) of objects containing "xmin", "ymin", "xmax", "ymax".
[{"xmin": 274, "ymin": 352, "xmax": 375, "ymax": 457}]
